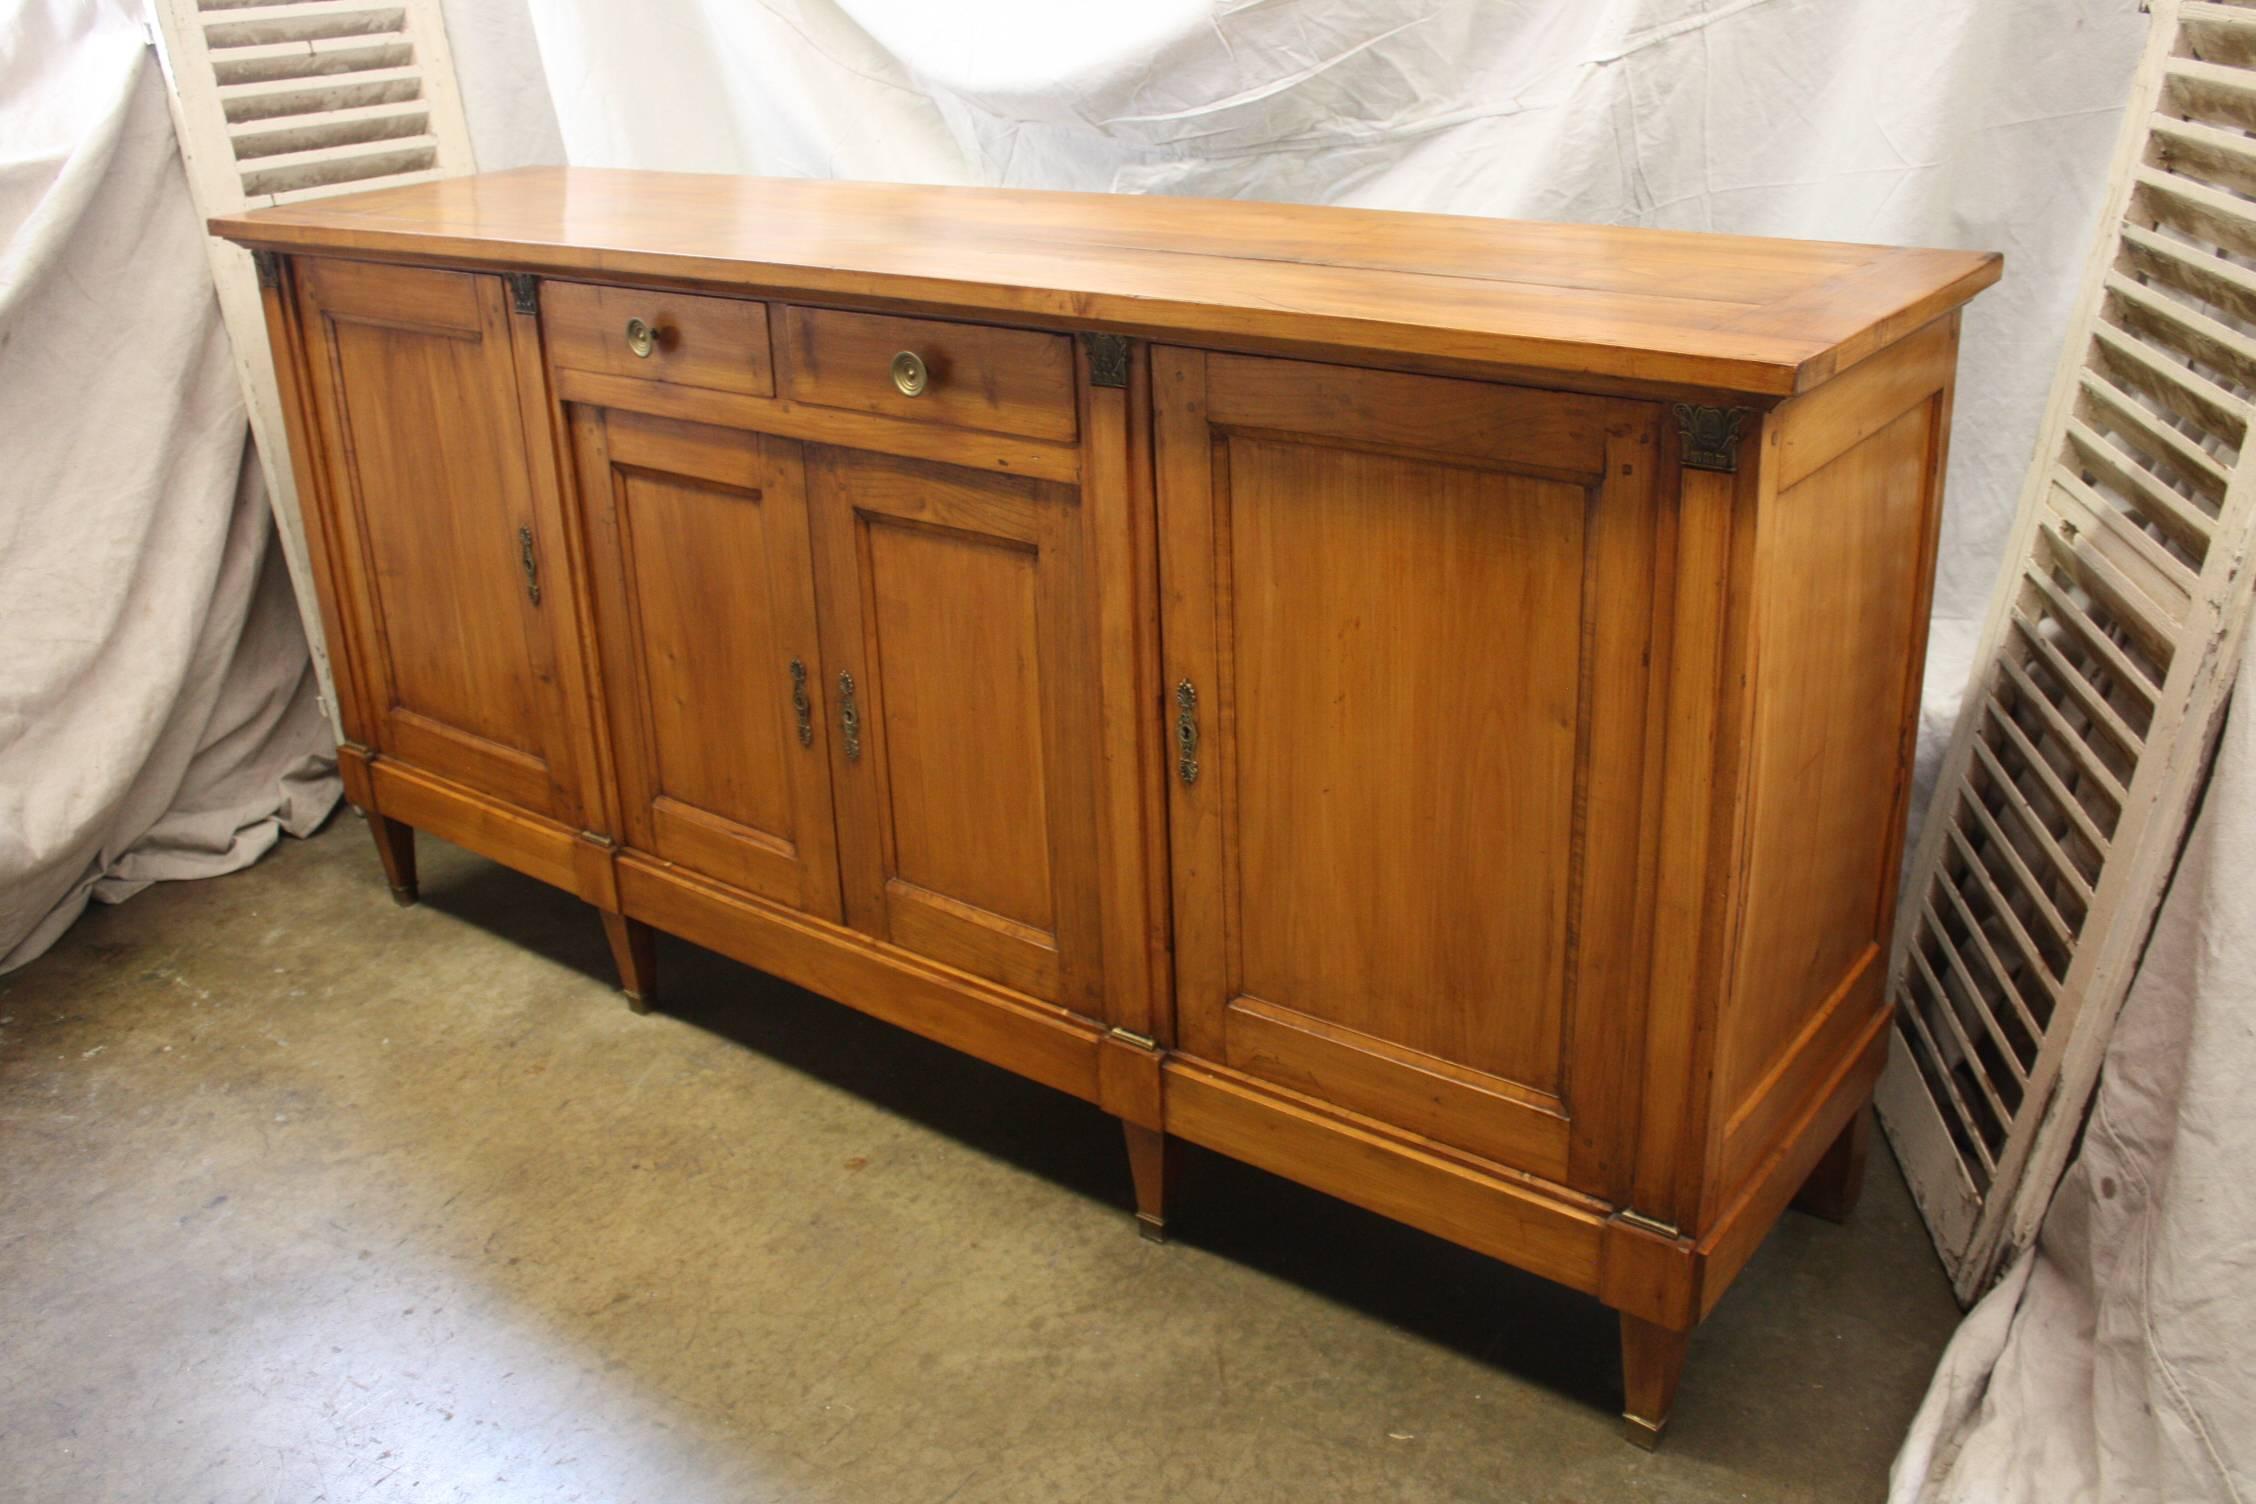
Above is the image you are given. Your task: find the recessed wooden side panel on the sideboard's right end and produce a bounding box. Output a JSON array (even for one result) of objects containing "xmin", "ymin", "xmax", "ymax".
[{"xmin": 1703, "ymin": 318, "xmax": 1958, "ymax": 1215}]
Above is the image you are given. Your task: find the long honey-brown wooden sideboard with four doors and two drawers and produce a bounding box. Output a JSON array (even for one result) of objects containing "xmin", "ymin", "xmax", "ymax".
[{"xmin": 214, "ymin": 169, "xmax": 1999, "ymax": 1443}]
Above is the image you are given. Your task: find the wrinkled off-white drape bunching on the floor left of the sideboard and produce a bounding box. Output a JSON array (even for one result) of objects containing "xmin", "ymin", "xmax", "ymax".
[{"xmin": 0, "ymin": 0, "xmax": 338, "ymax": 972}]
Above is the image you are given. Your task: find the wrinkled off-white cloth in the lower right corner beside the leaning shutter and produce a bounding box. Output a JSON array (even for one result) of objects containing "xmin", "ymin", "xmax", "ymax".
[{"xmin": 1891, "ymin": 640, "xmax": 2256, "ymax": 1504}]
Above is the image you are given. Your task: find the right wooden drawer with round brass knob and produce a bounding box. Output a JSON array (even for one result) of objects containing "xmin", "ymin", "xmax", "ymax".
[{"xmin": 776, "ymin": 307, "xmax": 1078, "ymax": 442}]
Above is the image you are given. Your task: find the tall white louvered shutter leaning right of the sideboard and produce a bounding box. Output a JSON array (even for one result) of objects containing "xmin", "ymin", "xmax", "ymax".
[{"xmin": 1879, "ymin": 0, "xmax": 2256, "ymax": 1301}]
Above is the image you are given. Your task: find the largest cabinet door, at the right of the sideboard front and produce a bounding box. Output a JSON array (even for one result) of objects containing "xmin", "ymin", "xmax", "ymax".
[{"xmin": 1153, "ymin": 350, "xmax": 1665, "ymax": 1186}]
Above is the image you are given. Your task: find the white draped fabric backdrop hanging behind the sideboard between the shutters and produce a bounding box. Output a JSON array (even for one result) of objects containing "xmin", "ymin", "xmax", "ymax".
[{"xmin": 532, "ymin": 0, "xmax": 2145, "ymax": 635}]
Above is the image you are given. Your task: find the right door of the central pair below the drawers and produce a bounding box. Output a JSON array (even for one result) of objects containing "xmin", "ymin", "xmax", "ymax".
[{"xmin": 808, "ymin": 449, "xmax": 1099, "ymax": 1015}]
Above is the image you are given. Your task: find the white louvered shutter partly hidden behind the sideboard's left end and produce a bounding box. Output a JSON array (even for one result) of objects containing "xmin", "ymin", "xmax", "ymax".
[{"xmin": 151, "ymin": 0, "xmax": 474, "ymax": 735}]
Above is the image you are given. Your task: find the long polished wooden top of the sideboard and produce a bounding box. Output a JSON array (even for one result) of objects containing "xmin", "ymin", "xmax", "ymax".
[{"xmin": 212, "ymin": 167, "xmax": 2001, "ymax": 395}]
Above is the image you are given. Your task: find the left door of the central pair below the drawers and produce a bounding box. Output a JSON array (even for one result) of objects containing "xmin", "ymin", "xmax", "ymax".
[{"xmin": 571, "ymin": 406, "xmax": 839, "ymax": 920}]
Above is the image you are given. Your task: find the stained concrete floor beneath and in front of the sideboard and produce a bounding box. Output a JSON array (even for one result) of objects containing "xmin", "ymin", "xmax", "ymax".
[{"xmin": 0, "ymin": 814, "xmax": 1958, "ymax": 1504}]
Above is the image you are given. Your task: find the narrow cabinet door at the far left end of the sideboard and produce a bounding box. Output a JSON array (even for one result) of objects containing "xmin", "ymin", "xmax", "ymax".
[{"xmin": 298, "ymin": 259, "xmax": 578, "ymax": 821}]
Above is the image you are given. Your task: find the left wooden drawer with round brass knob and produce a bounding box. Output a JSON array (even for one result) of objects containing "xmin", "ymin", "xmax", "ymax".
[{"xmin": 541, "ymin": 282, "xmax": 776, "ymax": 397}]
